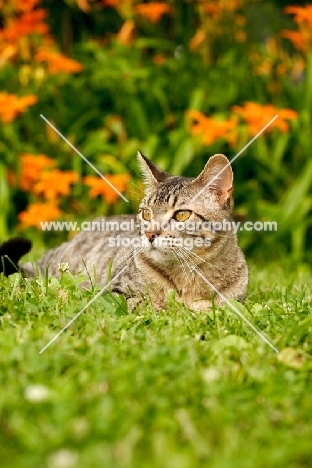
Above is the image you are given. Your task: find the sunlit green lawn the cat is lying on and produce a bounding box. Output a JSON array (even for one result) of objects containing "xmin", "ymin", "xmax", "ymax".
[{"xmin": 0, "ymin": 264, "xmax": 312, "ymax": 468}]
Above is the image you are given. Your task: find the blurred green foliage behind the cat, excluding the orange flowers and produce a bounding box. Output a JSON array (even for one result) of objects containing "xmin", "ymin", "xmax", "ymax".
[{"xmin": 0, "ymin": 1, "xmax": 312, "ymax": 261}]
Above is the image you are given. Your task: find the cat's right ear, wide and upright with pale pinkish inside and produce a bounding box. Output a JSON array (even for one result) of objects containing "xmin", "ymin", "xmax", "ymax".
[{"xmin": 193, "ymin": 154, "xmax": 233, "ymax": 204}]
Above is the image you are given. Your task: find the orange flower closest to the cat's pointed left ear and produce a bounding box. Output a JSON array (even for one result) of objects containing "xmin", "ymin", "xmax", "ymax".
[{"xmin": 83, "ymin": 174, "xmax": 130, "ymax": 204}]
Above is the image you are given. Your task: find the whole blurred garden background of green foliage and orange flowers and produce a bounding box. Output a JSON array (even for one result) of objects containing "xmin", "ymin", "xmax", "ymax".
[{"xmin": 0, "ymin": 0, "xmax": 312, "ymax": 262}]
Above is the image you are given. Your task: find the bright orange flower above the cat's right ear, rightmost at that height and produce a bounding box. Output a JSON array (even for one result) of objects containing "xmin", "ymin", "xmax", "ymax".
[{"xmin": 232, "ymin": 102, "xmax": 298, "ymax": 136}]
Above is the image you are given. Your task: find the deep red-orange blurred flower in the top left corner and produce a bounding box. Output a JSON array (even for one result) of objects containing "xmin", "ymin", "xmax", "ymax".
[{"xmin": 0, "ymin": 8, "xmax": 49, "ymax": 43}]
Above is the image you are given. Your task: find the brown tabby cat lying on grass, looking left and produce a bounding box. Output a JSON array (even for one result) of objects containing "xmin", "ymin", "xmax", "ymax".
[{"xmin": 0, "ymin": 153, "xmax": 248, "ymax": 311}]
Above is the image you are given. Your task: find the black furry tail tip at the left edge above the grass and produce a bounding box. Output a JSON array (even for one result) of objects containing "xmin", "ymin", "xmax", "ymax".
[{"xmin": 0, "ymin": 237, "xmax": 31, "ymax": 276}]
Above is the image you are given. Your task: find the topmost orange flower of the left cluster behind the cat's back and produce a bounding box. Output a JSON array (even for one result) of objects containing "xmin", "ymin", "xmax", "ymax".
[{"xmin": 19, "ymin": 153, "xmax": 55, "ymax": 192}]
